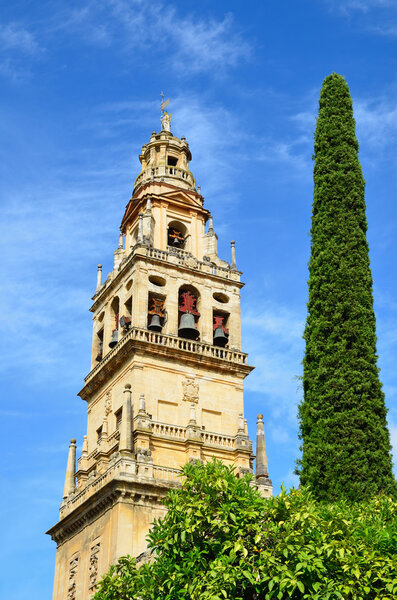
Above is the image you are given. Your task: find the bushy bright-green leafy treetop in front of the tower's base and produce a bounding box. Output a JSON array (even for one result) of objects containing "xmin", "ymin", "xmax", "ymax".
[{"xmin": 94, "ymin": 461, "xmax": 397, "ymax": 600}]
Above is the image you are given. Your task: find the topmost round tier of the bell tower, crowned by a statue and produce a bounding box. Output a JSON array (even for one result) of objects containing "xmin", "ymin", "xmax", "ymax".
[{"xmin": 133, "ymin": 112, "xmax": 196, "ymax": 194}]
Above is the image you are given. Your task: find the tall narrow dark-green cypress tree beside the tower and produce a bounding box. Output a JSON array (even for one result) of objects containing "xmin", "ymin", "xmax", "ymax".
[{"xmin": 298, "ymin": 73, "xmax": 396, "ymax": 500}]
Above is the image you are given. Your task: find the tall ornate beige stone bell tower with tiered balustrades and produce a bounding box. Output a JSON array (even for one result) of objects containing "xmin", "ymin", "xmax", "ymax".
[{"xmin": 48, "ymin": 113, "xmax": 272, "ymax": 600}]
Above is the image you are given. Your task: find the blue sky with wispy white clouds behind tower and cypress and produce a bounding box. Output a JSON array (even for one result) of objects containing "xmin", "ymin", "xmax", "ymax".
[{"xmin": 0, "ymin": 0, "xmax": 397, "ymax": 600}]
